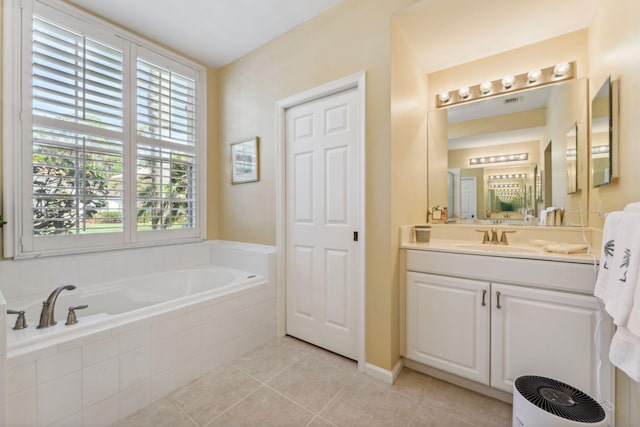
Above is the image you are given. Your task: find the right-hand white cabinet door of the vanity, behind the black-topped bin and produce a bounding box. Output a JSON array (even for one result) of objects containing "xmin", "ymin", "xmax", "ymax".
[{"xmin": 491, "ymin": 283, "xmax": 611, "ymax": 397}]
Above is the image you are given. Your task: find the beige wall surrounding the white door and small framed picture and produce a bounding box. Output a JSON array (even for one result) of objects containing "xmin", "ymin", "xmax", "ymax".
[{"xmin": 218, "ymin": 0, "xmax": 415, "ymax": 369}]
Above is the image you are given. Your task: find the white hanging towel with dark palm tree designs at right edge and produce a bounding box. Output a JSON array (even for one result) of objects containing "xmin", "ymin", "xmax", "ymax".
[{"xmin": 593, "ymin": 212, "xmax": 640, "ymax": 326}]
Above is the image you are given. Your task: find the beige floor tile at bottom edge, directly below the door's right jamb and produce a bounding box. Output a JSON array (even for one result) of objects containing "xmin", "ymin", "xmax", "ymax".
[{"xmin": 320, "ymin": 376, "xmax": 418, "ymax": 427}]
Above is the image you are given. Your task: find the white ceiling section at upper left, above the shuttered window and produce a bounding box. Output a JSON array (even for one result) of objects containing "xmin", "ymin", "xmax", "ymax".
[{"xmin": 67, "ymin": 0, "xmax": 341, "ymax": 68}]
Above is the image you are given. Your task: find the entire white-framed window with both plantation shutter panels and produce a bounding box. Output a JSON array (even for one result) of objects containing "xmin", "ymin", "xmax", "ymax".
[{"xmin": 5, "ymin": 0, "xmax": 206, "ymax": 257}]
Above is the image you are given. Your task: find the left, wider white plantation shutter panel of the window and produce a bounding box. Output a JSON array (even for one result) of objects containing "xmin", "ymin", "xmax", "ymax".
[{"xmin": 31, "ymin": 15, "xmax": 124, "ymax": 237}]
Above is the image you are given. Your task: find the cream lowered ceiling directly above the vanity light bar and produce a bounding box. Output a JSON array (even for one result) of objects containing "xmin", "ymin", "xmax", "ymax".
[{"xmin": 394, "ymin": 0, "xmax": 595, "ymax": 73}]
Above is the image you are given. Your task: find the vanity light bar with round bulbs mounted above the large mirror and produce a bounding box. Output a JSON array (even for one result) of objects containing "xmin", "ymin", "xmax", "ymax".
[{"xmin": 436, "ymin": 62, "xmax": 575, "ymax": 108}]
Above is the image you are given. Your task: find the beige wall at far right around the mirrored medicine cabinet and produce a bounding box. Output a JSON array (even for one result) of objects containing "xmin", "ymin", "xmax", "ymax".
[{"xmin": 589, "ymin": 0, "xmax": 640, "ymax": 427}]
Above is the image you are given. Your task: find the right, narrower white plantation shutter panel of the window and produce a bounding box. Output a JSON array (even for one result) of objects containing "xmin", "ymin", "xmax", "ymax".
[{"xmin": 136, "ymin": 52, "xmax": 198, "ymax": 231}]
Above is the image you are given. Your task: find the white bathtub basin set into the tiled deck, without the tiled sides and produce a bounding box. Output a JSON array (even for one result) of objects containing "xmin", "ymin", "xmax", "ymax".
[{"xmin": 7, "ymin": 266, "xmax": 266, "ymax": 357}]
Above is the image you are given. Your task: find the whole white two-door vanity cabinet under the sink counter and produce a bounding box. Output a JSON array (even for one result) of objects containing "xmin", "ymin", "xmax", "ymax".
[{"xmin": 404, "ymin": 250, "xmax": 613, "ymax": 400}]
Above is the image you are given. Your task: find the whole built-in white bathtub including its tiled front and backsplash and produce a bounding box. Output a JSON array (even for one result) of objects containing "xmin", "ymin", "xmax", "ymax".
[{"xmin": 0, "ymin": 241, "xmax": 276, "ymax": 426}]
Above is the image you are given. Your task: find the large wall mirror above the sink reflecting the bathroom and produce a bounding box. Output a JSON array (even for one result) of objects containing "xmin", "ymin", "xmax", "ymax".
[{"xmin": 428, "ymin": 79, "xmax": 588, "ymax": 226}]
